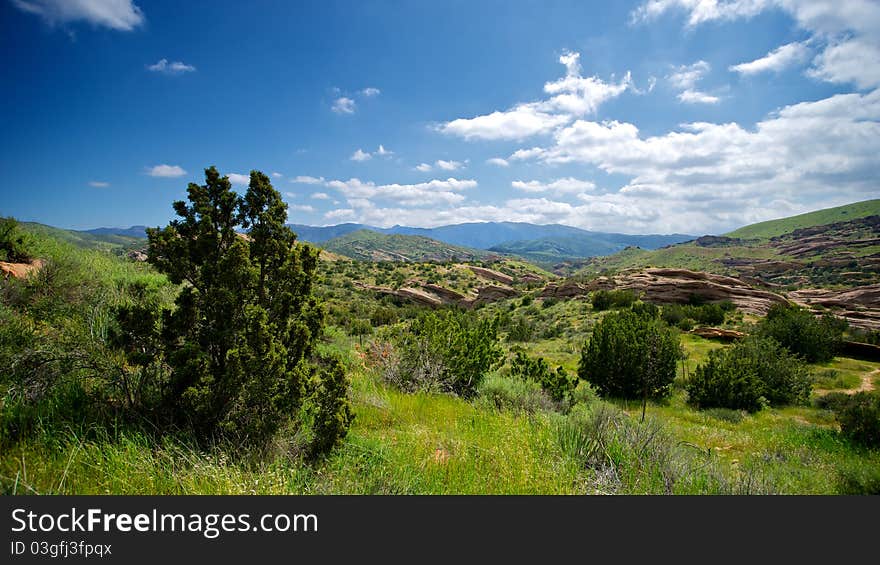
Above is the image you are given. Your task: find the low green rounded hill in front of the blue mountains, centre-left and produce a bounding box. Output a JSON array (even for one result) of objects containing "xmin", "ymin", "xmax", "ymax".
[{"xmin": 321, "ymin": 230, "xmax": 492, "ymax": 262}]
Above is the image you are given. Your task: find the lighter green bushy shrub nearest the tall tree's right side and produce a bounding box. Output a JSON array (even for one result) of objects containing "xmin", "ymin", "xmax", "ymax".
[{"xmin": 383, "ymin": 310, "xmax": 503, "ymax": 397}]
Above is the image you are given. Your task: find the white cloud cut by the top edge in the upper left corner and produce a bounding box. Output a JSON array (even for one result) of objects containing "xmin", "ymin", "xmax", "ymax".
[{"xmin": 12, "ymin": 0, "xmax": 144, "ymax": 31}]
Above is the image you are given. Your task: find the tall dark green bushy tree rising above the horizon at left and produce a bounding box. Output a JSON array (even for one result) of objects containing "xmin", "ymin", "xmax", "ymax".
[{"xmin": 147, "ymin": 167, "xmax": 350, "ymax": 452}]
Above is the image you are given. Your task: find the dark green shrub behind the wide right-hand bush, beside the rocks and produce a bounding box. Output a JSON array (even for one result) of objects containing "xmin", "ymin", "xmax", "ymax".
[{"xmin": 757, "ymin": 304, "xmax": 847, "ymax": 363}]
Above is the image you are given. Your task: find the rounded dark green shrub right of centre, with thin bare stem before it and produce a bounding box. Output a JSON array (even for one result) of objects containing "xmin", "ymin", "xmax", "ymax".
[{"xmin": 578, "ymin": 311, "xmax": 681, "ymax": 398}]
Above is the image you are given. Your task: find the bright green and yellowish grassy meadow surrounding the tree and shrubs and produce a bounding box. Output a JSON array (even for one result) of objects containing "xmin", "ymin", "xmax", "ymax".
[{"xmin": 0, "ymin": 220, "xmax": 880, "ymax": 494}]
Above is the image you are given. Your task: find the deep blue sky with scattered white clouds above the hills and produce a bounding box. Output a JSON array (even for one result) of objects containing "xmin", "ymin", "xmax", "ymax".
[{"xmin": 0, "ymin": 0, "xmax": 880, "ymax": 234}]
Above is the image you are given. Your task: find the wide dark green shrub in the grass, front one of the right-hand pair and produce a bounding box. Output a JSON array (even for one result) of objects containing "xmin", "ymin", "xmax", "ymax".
[{"xmin": 685, "ymin": 337, "xmax": 811, "ymax": 412}]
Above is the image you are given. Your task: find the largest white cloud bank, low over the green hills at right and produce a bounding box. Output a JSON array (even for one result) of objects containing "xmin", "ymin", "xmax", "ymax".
[{"xmin": 498, "ymin": 89, "xmax": 880, "ymax": 234}]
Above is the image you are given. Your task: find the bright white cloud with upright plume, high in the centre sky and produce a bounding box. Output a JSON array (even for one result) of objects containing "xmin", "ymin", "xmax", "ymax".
[{"xmin": 437, "ymin": 52, "xmax": 632, "ymax": 140}]
